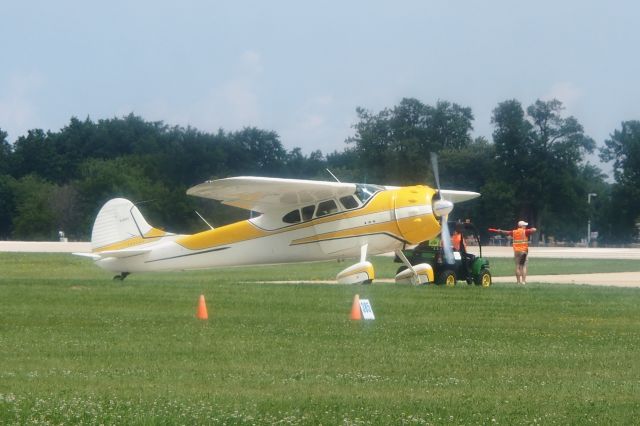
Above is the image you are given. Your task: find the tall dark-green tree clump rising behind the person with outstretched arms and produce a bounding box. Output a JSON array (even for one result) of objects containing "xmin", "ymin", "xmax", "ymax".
[{"xmin": 492, "ymin": 100, "xmax": 595, "ymax": 238}]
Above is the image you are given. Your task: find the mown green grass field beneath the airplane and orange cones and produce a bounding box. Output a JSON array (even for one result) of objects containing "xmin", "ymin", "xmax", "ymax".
[{"xmin": 0, "ymin": 253, "xmax": 640, "ymax": 425}]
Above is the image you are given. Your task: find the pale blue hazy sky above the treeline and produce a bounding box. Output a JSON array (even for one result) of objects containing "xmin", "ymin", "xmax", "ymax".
[{"xmin": 0, "ymin": 0, "xmax": 640, "ymax": 172}]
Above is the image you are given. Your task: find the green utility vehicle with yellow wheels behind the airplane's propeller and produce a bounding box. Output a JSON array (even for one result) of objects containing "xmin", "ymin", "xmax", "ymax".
[{"xmin": 395, "ymin": 222, "xmax": 491, "ymax": 287}]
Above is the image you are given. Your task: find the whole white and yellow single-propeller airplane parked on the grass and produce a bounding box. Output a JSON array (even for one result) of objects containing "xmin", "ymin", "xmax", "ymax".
[{"xmin": 74, "ymin": 158, "xmax": 480, "ymax": 284}]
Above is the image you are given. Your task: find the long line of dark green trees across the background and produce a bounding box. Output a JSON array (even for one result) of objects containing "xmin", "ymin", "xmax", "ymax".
[{"xmin": 0, "ymin": 98, "xmax": 640, "ymax": 244}]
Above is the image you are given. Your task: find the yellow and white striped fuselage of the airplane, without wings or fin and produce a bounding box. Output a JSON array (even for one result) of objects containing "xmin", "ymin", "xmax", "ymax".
[{"xmin": 94, "ymin": 186, "xmax": 440, "ymax": 272}]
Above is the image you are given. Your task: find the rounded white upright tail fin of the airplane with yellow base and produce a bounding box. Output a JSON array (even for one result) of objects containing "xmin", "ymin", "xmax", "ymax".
[{"xmin": 91, "ymin": 198, "xmax": 166, "ymax": 252}]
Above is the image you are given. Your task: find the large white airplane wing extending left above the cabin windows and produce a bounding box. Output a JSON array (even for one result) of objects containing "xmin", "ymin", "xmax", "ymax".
[{"xmin": 187, "ymin": 176, "xmax": 356, "ymax": 213}]
